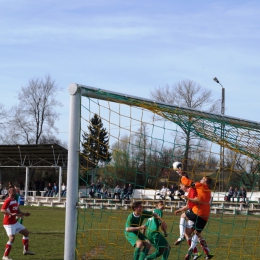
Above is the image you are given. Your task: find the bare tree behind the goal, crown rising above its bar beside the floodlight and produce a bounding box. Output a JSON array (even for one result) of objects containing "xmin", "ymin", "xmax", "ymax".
[{"xmin": 150, "ymin": 79, "xmax": 220, "ymax": 170}]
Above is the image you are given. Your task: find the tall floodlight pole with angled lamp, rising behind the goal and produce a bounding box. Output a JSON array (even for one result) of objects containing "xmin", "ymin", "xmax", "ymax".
[{"xmin": 213, "ymin": 77, "xmax": 225, "ymax": 191}]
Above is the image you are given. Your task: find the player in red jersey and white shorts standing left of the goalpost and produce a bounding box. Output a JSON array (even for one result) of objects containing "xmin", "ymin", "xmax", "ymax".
[{"xmin": 1, "ymin": 186, "xmax": 35, "ymax": 260}]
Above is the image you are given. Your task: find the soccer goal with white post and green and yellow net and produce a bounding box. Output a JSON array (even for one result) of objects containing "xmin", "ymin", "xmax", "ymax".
[{"xmin": 64, "ymin": 84, "xmax": 260, "ymax": 260}]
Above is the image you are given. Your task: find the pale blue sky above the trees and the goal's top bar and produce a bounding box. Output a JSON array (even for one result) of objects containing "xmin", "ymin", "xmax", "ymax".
[{"xmin": 0, "ymin": 0, "xmax": 260, "ymax": 141}]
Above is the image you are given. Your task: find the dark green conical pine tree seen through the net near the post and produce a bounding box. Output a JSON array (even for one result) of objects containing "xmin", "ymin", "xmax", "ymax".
[{"xmin": 82, "ymin": 114, "xmax": 112, "ymax": 168}]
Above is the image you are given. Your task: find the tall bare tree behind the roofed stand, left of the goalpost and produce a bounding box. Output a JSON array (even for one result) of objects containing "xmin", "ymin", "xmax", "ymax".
[{"xmin": 10, "ymin": 75, "xmax": 61, "ymax": 144}]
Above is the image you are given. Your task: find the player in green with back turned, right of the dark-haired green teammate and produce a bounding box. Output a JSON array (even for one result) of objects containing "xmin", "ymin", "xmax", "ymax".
[{"xmin": 145, "ymin": 201, "xmax": 171, "ymax": 260}]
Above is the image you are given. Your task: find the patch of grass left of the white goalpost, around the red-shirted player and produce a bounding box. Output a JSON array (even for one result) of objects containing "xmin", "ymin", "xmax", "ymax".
[{"xmin": 0, "ymin": 206, "xmax": 65, "ymax": 260}]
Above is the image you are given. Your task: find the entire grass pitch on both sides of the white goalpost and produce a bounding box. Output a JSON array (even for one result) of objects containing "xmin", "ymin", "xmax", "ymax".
[{"xmin": 0, "ymin": 206, "xmax": 260, "ymax": 260}]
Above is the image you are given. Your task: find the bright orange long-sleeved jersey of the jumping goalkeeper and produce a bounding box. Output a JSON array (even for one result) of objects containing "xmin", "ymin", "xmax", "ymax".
[{"xmin": 181, "ymin": 176, "xmax": 211, "ymax": 220}]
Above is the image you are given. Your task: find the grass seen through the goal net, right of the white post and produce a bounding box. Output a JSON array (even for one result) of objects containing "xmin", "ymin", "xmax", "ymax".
[{"xmin": 78, "ymin": 209, "xmax": 260, "ymax": 260}]
